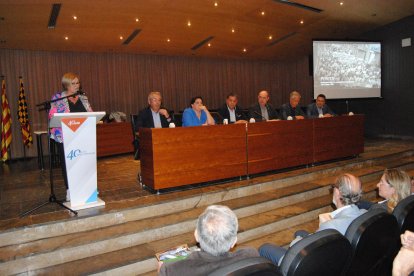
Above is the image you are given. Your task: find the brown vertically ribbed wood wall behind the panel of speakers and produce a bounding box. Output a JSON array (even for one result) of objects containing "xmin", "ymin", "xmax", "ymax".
[{"xmin": 0, "ymin": 49, "xmax": 312, "ymax": 158}]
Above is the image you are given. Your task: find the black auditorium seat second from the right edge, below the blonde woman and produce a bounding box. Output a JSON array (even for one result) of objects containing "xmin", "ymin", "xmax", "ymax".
[{"xmin": 345, "ymin": 208, "xmax": 400, "ymax": 275}]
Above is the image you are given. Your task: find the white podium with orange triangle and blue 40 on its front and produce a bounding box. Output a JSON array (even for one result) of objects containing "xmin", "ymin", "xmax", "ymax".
[{"xmin": 50, "ymin": 112, "xmax": 105, "ymax": 210}]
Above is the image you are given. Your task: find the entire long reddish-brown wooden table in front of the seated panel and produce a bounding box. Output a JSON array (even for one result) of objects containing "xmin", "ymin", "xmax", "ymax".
[{"xmin": 139, "ymin": 115, "xmax": 364, "ymax": 190}]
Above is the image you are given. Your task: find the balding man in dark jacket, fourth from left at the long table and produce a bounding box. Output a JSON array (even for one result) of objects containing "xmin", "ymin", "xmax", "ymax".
[{"xmin": 249, "ymin": 90, "xmax": 279, "ymax": 122}]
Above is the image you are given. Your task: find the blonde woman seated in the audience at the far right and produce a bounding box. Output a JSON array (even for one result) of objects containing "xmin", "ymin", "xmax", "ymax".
[{"xmin": 359, "ymin": 169, "xmax": 411, "ymax": 213}]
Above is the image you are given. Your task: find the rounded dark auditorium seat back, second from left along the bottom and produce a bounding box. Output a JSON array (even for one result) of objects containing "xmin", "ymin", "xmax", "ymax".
[{"xmin": 280, "ymin": 229, "xmax": 352, "ymax": 276}]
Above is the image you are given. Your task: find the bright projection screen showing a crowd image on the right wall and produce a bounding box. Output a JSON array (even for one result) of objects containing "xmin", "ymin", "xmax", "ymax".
[{"xmin": 313, "ymin": 41, "xmax": 381, "ymax": 98}]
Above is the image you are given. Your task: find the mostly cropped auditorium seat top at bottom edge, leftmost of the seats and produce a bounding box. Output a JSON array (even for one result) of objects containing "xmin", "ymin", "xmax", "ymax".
[{"xmin": 209, "ymin": 257, "xmax": 282, "ymax": 276}]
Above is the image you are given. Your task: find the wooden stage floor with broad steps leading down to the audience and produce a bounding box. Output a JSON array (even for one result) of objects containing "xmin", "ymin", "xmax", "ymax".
[{"xmin": 0, "ymin": 139, "xmax": 414, "ymax": 275}]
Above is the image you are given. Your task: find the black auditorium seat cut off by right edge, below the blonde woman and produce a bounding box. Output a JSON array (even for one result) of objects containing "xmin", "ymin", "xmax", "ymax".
[{"xmin": 392, "ymin": 195, "xmax": 414, "ymax": 233}]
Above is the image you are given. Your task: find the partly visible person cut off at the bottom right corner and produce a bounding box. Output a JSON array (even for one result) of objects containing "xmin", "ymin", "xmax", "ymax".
[{"xmin": 392, "ymin": 231, "xmax": 414, "ymax": 276}]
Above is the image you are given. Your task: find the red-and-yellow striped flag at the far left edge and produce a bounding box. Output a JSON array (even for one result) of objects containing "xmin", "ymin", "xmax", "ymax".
[{"xmin": 1, "ymin": 79, "xmax": 12, "ymax": 161}]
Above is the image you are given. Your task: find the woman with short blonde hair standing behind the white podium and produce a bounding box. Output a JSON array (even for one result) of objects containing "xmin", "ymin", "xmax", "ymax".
[{"xmin": 49, "ymin": 73, "xmax": 92, "ymax": 201}]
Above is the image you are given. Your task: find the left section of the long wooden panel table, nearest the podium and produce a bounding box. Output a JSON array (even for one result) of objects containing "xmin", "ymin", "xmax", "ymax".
[{"xmin": 139, "ymin": 124, "xmax": 247, "ymax": 190}]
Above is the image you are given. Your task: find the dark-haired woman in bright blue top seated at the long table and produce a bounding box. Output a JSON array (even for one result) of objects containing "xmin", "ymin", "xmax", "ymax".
[{"xmin": 183, "ymin": 96, "xmax": 215, "ymax": 127}]
